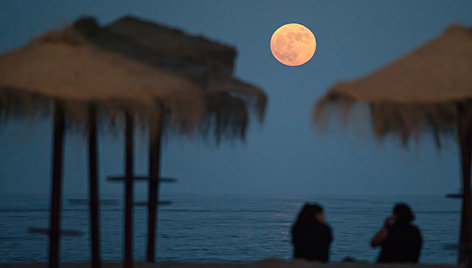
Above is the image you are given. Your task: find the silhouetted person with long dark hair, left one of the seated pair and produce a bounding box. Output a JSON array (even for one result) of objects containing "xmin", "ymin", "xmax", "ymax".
[{"xmin": 292, "ymin": 203, "xmax": 333, "ymax": 262}]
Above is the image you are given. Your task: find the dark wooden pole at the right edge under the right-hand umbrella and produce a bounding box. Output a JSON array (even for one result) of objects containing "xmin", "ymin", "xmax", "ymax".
[{"xmin": 457, "ymin": 107, "xmax": 472, "ymax": 268}]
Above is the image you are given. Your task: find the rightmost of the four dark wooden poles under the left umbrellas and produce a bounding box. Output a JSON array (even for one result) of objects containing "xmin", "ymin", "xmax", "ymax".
[{"xmin": 146, "ymin": 106, "xmax": 164, "ymax": 262}]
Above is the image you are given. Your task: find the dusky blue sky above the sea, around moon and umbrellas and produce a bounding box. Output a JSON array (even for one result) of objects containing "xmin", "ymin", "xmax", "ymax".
[{"xmin": 0, "ymin": 0, "xmax": 472, "ymax": 194}]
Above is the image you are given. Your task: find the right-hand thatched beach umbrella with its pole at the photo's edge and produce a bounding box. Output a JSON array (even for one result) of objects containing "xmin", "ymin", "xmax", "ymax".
[{"xmin": 314, "ymin": 25, "xmax": 472, "ymax": 267}]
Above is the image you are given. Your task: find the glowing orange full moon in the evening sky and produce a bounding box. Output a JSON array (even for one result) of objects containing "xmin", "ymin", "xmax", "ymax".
[{"xmin": 270, "ymin": 23, "xmax": 316, "ymax": 66}]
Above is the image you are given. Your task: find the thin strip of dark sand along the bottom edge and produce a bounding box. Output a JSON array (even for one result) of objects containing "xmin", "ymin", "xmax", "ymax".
[{"xmin": 0, "ymin": 259, "xmax": 462, "ymax": 268}]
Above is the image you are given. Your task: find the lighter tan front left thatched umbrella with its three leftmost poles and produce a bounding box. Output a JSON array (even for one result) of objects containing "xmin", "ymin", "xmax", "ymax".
[{"xmin": 0, "ymin": 23, "xmax": 205, "ymax": 267}]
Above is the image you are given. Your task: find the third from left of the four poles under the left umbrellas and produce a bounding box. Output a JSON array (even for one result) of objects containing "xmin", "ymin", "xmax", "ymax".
[{"xmin": 124, "ymin": 112, "xmax": 134, "ymax": 268}]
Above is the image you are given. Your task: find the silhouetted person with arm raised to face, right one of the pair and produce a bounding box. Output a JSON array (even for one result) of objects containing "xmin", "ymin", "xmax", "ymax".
[{"xmin": 370, "ymin": 203, "xmax": 423, "ymax": 263}]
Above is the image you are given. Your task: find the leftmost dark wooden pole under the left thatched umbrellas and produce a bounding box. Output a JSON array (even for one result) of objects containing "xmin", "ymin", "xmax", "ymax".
[{"xmin": 49, "ymin": 102, "xmax": 65, "ymax": 268}]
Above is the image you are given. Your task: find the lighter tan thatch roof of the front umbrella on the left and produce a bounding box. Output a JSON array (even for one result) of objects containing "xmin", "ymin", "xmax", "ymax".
[{"xmin": 0, "ymin": 23, "xmax": 205, "ymax": 130}]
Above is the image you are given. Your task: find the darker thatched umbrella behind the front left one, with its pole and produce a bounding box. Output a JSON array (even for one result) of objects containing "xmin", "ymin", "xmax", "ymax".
[{"xmin": 76, "ymin": 14, "xmax": 267, "ymax": 262}]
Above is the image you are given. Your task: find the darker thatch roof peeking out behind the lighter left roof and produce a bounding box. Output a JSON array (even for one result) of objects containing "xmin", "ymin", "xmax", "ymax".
[{"xmin": 104, "ymin": 17, "xmax": 267, "ymax": 140}]
